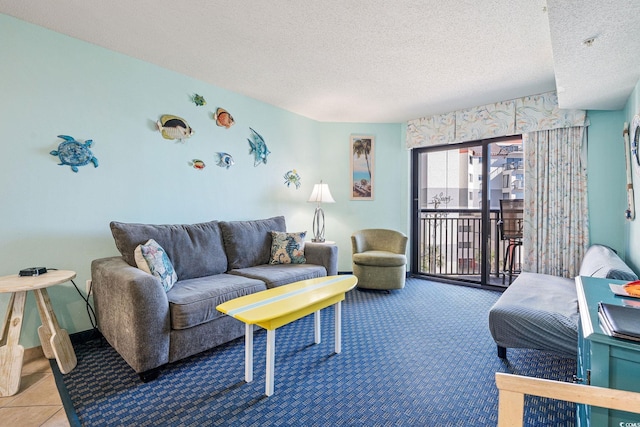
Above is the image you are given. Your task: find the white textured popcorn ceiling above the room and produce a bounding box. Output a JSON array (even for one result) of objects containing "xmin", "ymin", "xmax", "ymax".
[{"xmin": 0, "ymin": 0, "xmax": 640, "ymax": 123}]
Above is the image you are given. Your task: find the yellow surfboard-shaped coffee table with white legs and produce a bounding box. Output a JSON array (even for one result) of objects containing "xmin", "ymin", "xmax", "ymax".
[{"xmin": 216, "ymin": 275, "xmax": 358, "ymax": 396}]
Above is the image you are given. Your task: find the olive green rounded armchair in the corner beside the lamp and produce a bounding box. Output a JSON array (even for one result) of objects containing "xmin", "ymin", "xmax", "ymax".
[{"xmin": 351, "ymin": 229, "xmax": 407, "ymax": 291}]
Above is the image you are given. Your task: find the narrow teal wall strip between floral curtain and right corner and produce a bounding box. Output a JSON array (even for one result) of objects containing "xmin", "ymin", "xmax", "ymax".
[{"xmin": 587, "ymin": 111, "xmax": 627, "ymax": 254}]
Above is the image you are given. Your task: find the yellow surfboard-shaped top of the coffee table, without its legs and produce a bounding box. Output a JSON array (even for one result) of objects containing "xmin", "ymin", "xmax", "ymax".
[{"xmin": 216, "ymin": 275, "xmax": 358, "ymax": 324}]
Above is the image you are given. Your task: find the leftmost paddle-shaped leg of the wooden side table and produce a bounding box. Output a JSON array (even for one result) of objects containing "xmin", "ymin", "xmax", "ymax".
[{"xmin": 0, "ymin": 291, "xmax": 27, "ymax": 397}]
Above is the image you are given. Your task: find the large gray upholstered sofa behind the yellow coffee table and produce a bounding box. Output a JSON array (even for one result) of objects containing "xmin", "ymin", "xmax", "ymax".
[{"xmin": 91, "ymin": 216, "xmax": 338, "ymax": 381}]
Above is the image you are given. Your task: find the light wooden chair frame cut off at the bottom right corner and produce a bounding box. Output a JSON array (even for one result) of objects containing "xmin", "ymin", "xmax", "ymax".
[{"xmin": 496, "ymin": 372, "xmax": 640, "ymax": 427}]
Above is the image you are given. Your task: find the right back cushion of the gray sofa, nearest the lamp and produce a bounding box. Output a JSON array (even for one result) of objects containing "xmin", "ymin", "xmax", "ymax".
[{"xmin": 220, "ymin": 216, "xmax": 287, "ymax": 270}]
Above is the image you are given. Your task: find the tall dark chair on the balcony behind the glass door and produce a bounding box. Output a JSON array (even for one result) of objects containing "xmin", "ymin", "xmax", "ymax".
[{"xmin": 498, "ymin": 199, "xmax": 524, "ymax": 284}]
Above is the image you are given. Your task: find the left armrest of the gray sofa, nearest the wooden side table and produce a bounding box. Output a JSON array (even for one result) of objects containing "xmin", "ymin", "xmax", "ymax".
[{"xmin": 91, "ymin": 257, "xmax": 171, "ymax": 373}]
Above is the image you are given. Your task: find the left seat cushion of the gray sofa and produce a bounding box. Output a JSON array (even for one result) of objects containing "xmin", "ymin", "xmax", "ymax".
[{"xmin": 167, "ymin": 274, "xmax": 266, "ymax": 329}]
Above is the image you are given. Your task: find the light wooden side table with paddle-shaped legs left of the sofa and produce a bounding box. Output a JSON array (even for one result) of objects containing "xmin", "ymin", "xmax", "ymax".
[{"xmin": 0, "ymin": 270, "xmax": 77, "ymax": 396}]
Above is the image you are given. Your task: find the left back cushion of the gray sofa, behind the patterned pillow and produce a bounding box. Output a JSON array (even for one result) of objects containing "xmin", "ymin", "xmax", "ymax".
[{"xmin": 109, "ymin": 221, "xmax": 227, "ymax": 280}]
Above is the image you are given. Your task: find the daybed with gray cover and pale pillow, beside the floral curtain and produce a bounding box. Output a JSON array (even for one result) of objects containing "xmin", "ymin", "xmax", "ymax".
[{"xmin": 489, "ymin": 245, "xmax": 638, "ymax": 358}]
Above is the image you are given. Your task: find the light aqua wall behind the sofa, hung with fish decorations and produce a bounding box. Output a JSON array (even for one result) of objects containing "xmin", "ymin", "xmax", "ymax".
[{"xmin": 0, "ymin": 15, "xmax": 409, "ymax": 348}]
